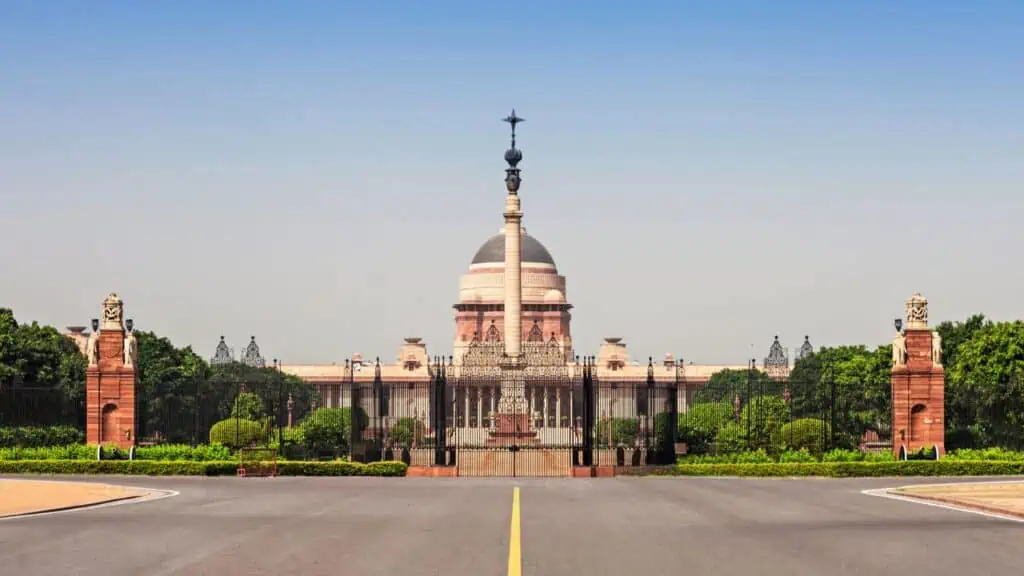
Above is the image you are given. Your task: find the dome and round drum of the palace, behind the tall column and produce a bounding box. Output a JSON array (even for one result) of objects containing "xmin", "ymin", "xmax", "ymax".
[{"xmin": 452, "ymin": 229, "xmax": 572, "ymax": 362}]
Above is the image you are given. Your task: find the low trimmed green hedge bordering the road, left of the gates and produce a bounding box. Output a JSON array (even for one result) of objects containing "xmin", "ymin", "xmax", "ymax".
[{"xmin": 0, "ymin": 460, "xmax": 407, "ymax": 477}]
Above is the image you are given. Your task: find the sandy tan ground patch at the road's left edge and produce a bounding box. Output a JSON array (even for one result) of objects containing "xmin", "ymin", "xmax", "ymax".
[{"xmin": 0, "ymin": 480, "xmax": 148, "ymax": 518}]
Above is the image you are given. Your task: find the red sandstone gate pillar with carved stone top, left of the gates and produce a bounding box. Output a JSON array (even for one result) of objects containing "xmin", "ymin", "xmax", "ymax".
[{"xmin": 85, "ymin": 294, "xmax": 138, "ymax": 449}]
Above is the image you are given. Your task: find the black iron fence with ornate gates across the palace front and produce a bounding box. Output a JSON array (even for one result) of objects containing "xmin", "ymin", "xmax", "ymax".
[{"xmin": 8, "ymin": 366, "xmax": 1024, "ymax": 461}]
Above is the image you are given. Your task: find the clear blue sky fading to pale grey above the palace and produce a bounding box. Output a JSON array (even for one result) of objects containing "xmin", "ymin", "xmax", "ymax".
[{"xmin": 0, "ymin": 0, "xmax": 1024, "ymax": 364}]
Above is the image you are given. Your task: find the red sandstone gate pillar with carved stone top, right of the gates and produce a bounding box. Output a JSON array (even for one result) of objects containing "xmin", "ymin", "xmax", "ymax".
[{"xmin": 892, "ymin": 292, "xmax": 945, "ymax": 457}]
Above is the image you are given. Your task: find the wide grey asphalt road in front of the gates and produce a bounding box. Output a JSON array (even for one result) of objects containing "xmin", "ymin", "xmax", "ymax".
[{"xmin": 0, "ymin": 478, "xmax": 1024, "ymax": 576}]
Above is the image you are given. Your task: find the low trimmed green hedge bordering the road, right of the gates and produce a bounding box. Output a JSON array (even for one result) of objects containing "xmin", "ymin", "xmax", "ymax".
[{"xmin": 675, "ymin": 460, "xmax": 1024, "ymax": 478}]
